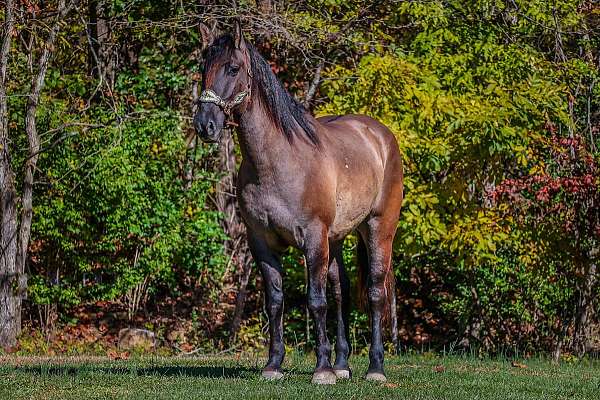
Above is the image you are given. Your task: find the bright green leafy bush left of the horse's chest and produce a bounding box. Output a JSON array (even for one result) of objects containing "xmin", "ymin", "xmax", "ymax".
[{"xmin": 30, "ymin": 110, "xmax": 225, "ymax": 306}]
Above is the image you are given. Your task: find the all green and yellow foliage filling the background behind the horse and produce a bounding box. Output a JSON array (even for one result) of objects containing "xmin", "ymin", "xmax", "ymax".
[{"xmin": 8, "ymin": 0, "xmax": 600, "ymax": 352}]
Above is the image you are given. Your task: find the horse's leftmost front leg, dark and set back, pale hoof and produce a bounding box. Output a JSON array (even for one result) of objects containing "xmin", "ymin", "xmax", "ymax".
[{"xmin": 248, "ymin": 235, "xmax": 285, "ymax": 380}]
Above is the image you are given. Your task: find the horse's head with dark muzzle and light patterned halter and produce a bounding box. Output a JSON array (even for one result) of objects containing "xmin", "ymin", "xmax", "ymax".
[{"xmin": 194, "ymin": 20, "xmax": 251, "ymax": 142}]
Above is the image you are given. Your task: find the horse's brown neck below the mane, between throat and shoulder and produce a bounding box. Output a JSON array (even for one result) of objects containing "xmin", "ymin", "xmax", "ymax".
[{"xmin": 238, "ymin": 98, "xmax": 292, "ymax": 175}]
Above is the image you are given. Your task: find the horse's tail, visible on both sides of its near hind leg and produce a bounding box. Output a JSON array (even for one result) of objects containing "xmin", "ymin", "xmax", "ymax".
[{"xmin": 356, "ymin": 235, "xmax": 395, "ymax": 326}]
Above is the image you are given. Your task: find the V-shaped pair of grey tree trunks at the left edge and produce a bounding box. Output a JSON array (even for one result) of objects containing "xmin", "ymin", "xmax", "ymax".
[{"xmin": 0, "ymin": 0, "xmax": 75, "ymax": 348}]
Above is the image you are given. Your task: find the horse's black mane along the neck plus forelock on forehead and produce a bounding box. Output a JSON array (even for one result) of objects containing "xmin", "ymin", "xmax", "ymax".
[{"xmin": 205, "ymin": 34, "xmax": 319, "ymax": 145}]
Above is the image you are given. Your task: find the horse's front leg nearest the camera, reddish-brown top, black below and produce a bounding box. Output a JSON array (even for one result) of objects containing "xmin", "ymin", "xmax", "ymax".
[{"xmin": 303, "ymin": 224, "xmax": 336, "ymax": 384}]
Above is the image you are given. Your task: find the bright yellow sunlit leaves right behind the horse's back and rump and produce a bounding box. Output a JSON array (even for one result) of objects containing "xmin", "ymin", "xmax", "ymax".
[{"xmin": 321, "ymin": 42, "xmax": 564, "ymax": 262}]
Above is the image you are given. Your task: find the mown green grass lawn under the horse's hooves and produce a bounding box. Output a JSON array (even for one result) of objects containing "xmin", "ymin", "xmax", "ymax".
[{"xmin": 0, "ymin": 354, "xmax": 600, "ymax": 400}]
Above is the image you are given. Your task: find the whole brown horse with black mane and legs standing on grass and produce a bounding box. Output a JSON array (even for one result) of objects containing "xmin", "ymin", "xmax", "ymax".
[{"xmin": 194, "ymin": 22, "xmax": 403, "ymax": 384}]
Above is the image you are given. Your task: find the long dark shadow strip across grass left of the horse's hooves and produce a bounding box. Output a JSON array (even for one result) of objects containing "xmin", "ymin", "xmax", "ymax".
[{"xmin": 15, "ymin": 365, "xmax": 260, "ymax": 379}]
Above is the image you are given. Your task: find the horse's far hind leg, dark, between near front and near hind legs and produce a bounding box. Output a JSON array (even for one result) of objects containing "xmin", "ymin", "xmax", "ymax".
[{"xmin": 328, "ymin": 242, "xmax": 351, "ymax": 379}]
